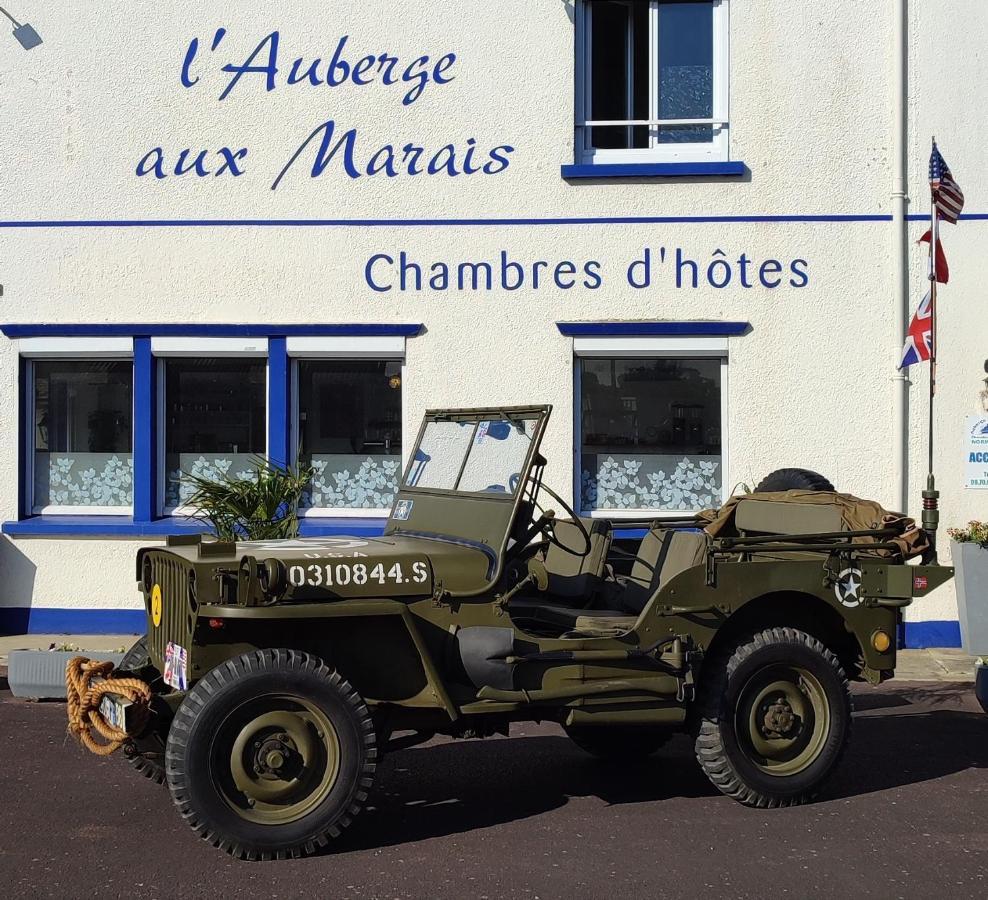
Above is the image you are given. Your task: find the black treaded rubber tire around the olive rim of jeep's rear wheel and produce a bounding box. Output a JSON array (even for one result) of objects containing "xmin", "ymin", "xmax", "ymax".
[{"xmin": 694, "ymin": 627, "xmax": 852, "ymax": 809}]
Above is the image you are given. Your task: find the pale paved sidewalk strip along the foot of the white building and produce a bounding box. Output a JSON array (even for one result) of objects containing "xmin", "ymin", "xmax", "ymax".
[{"xmin": 0, "ymin": 634, "xmax": 976, "ymax": 682}]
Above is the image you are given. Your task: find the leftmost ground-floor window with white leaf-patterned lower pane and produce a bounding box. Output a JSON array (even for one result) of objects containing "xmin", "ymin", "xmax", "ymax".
[{"xmin": 29, "ymin": 359, "xmax": 134, "ymax": 513}]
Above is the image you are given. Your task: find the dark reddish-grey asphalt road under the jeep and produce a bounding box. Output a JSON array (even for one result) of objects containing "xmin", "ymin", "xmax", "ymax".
[{"xmin": 0, "ymin": 682, "xmax": 988, "ymax": 900}]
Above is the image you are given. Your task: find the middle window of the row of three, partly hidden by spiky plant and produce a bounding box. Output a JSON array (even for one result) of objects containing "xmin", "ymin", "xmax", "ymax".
[{"xmin": 161, "ymin": 357, "xmax": 267, "ymax": 513}]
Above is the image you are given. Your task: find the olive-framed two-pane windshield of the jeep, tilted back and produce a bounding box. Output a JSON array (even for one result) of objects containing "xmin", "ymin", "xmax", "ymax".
[{"xmin": 384, "ymin": 405, "xmax": 552, "ymax": 596}]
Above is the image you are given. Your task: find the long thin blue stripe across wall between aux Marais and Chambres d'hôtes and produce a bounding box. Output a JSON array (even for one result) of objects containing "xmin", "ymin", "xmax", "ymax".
[{"xmin": 0, "ymin": 213, "xmax": 988, "ymax": 229}]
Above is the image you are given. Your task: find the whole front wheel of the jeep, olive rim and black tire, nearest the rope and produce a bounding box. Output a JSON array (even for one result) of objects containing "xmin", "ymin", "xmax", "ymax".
[{"xmin": 165, "ymin": 650, "xmax": 377, "ymax": 859}]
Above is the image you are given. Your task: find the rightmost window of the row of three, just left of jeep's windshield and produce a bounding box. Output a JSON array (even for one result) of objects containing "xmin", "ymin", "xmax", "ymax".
[{"xmin": 296, "ymin": 359, "xmax": 401, "ymax": 514}]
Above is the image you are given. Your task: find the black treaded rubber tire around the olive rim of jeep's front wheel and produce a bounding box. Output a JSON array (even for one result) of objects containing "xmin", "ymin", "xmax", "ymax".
[{"xmin": 165, "ymin": 649, "xmax": 378, "ymax": 861}]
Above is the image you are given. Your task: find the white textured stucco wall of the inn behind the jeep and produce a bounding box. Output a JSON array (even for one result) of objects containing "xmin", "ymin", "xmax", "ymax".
[{"xmin": 0, "ymin": 0, "xmax": 988, "ymax": 620}]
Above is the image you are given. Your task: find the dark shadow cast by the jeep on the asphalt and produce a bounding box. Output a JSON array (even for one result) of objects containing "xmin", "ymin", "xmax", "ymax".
[{"xmin": 327, "ymin": 684, "xmax": 988, "ymax": 853}]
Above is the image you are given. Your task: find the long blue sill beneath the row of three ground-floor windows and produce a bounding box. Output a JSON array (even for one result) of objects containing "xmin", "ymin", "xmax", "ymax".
[{"xmin": 0, "ymin": 516, "xmax": 387, "ymax": 538}]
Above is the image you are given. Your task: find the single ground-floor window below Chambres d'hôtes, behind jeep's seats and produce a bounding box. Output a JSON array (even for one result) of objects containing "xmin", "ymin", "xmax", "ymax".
[{"xmin": 577, "ymin": 357, "xmax": 727, "ymax": 513}]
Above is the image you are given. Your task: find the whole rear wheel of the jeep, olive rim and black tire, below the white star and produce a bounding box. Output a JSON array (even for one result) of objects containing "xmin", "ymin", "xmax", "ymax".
[{"xmin": 696, "ymin": 628, "xmax": 851, "ymax": 808}]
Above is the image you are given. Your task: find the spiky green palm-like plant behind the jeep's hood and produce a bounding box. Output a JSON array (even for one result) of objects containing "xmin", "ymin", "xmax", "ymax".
[{"xmin": 187, "ymin": 457, "xmax": 312, "ymax": 541}]
